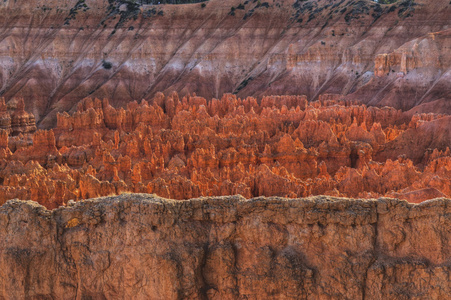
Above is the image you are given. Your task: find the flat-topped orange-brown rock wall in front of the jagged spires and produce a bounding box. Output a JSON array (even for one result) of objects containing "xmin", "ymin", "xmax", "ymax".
[{"xmin": 0, "ymin": 194, "xmax": 451, "ymax": 299}]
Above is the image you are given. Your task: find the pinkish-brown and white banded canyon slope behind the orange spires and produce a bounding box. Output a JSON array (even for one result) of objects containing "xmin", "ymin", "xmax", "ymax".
[{"xmin": 0, "ymin": 0, "xmax": 451, "ymax": 128}]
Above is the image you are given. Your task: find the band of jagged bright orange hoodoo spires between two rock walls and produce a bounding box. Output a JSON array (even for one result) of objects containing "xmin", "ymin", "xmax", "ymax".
[{"xmin": 0, "ymin": 93, "xmax": 451, "ymax": 208}]
